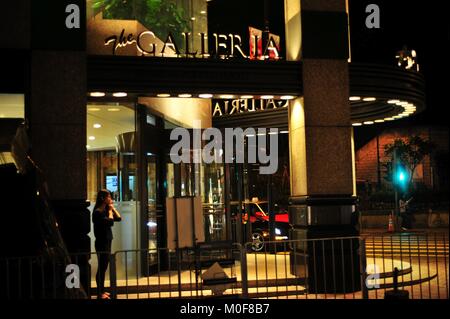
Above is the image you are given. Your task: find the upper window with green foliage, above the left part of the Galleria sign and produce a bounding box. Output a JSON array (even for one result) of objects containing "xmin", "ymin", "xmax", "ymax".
[{"xmin": 87, "ymin": 0, "xmax": 208, "ymax": 56}]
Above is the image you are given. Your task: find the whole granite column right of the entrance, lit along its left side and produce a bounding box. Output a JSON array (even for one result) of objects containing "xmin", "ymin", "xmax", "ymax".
[{"xmin": 287, "ymin": 0, "xmax": 359, "ymax": 292}]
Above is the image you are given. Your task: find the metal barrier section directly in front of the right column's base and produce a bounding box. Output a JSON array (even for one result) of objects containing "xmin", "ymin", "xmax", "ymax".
[{"xmin": 243, "ymin": 237, "xmax": 364, "ymax": 299}]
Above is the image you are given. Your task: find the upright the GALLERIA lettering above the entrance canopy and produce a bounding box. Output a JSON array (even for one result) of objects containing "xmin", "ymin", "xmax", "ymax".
[{"xmin": 104, "ymin": 28, "xmax": 280, "ymax": 60}]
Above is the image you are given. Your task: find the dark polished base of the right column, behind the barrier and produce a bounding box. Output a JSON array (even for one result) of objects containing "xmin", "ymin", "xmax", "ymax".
[{"xmin": 289, "ymin": 196, "xmax": 361, "ymax": 294}]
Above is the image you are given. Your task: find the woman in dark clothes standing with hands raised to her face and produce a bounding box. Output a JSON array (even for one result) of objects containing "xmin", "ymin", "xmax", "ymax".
[{"xmin": 92, "ymin": 189, "xmax": 122, "ymax": 299}]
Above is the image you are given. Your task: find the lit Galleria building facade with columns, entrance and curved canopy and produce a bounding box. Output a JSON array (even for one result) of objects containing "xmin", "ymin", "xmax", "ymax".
[{"xmin": 0, "ymin": 0, "xmax": 425, "ymax": 292}]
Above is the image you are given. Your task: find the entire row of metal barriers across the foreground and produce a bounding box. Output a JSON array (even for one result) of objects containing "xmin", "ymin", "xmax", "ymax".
[{"xmin": 0, "ymin": 233, "xmax": 449, "ymax": 300}]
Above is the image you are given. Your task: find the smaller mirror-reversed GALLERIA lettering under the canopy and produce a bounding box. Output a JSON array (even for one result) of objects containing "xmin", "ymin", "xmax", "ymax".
[{"xmin": 212, "ymin": 99, "xmax": 289, "ymax": 117}]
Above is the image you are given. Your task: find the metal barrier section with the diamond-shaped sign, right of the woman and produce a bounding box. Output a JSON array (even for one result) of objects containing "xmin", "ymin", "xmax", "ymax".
[{"xmin": 109, "ymin": 244, "xmax": 242, "ymax": 299}]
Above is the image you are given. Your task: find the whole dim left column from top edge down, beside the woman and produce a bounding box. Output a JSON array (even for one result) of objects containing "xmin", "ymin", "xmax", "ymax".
[{"xmin": 27, "ymin": 0, "xmax": 90, "ymax": 253}]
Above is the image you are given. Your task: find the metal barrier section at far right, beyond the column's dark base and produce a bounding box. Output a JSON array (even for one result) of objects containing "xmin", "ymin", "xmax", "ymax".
[{"xmin": 365, "ymin": 232, "xmax": 449, "ymax": 299}]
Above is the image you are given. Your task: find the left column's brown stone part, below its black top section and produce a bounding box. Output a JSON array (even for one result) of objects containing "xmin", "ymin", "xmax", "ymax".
[{"xmin": 28, "ymin": 50, "xmax": 90, "ymax": 253}]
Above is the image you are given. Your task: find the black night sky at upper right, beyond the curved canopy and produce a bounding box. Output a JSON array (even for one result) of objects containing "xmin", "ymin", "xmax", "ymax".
[{"xmin": 349, "ymin": 0, "xmax": 450, "ymax": 148}]
